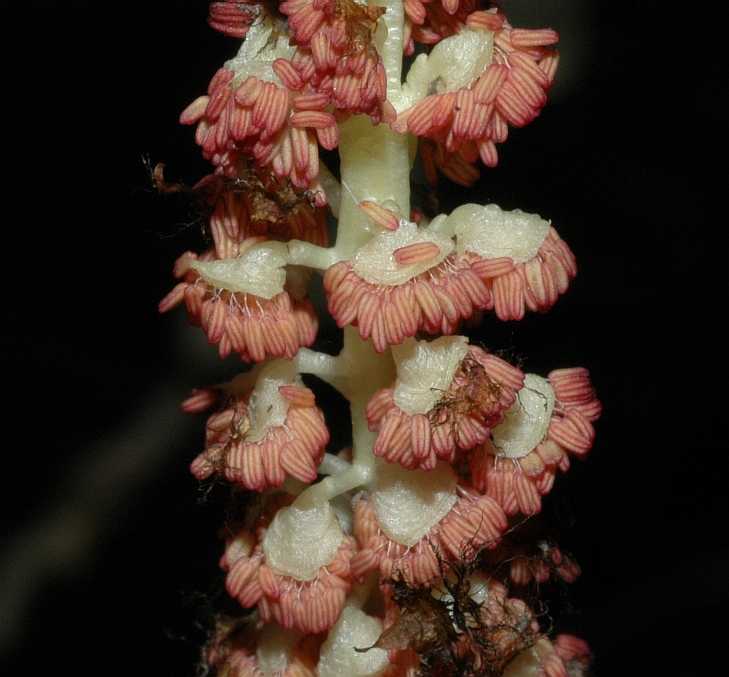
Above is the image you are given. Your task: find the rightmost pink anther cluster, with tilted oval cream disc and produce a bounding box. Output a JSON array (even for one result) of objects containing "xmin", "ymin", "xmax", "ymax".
[{"xmin": 470, "ymin": 368, "xmax": 602, "ymax": 515}]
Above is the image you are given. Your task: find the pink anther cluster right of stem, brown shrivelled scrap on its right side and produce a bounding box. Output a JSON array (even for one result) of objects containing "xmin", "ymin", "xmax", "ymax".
[{"xmin": 366, "ymin": 336, "xmax": 524, "ymax": 470}]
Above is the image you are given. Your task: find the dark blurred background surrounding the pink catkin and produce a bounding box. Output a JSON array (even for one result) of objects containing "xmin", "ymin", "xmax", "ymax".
[{"xmin": 0, "ymin": 0, "xmax": 729, "ymax": 677}]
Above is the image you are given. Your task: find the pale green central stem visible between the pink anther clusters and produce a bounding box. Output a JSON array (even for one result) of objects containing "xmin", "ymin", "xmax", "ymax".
[{"xmin": 296, "ymin": 0, "xmax": 411, "ymax": 506}]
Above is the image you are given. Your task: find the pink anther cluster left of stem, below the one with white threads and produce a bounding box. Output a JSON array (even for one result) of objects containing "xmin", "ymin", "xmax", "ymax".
[{"xmin": 191, "ymin": 364, "xmax": 329, "ymax": 491}]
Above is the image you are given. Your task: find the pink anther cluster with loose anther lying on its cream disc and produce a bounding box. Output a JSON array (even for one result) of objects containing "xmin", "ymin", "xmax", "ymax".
[{"xmin": 324, "ymin": 222, "xmax": 492, "ymax": 352}]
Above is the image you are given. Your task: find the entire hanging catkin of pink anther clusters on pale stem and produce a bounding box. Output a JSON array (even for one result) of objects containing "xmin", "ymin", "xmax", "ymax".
[{"xmin": 160, "ymin": 0, "xmax": 600, "ymax": 677}]
